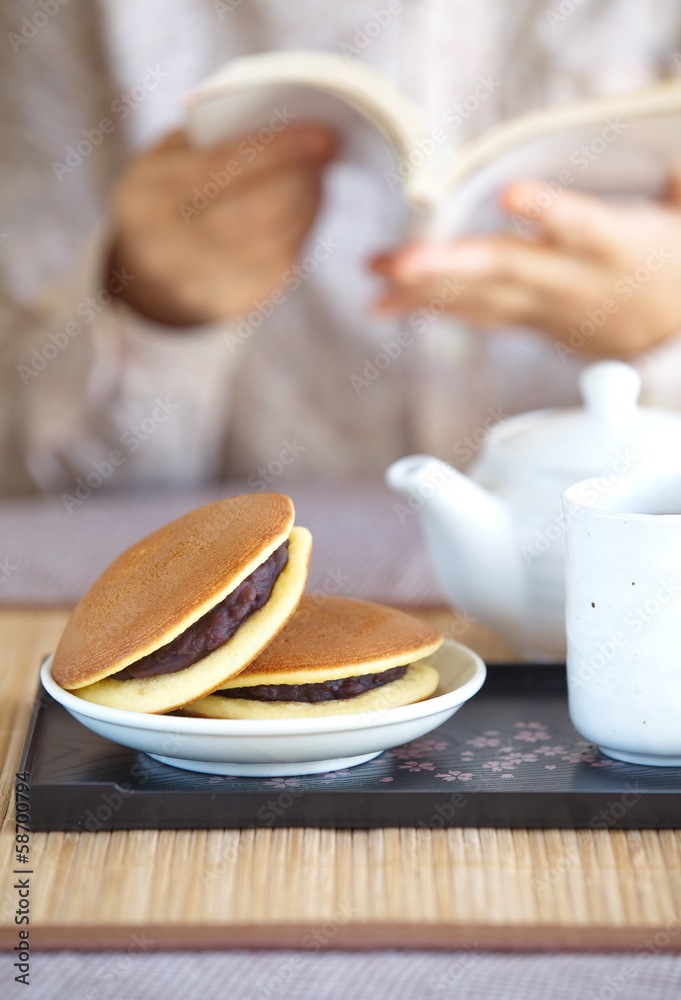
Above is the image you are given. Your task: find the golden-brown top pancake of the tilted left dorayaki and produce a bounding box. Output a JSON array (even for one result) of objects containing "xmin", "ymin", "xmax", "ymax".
[{"xmin": 52, "ymin": 493, "xmax": 295, "ymax": 687}]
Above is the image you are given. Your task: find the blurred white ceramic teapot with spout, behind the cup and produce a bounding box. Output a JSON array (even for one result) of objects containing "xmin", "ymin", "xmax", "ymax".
[{"xmin": 386, "ymin": 361, "xmax": 681, "ymax": 659}]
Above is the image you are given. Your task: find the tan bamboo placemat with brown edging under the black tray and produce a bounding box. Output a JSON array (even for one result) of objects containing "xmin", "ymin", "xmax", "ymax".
[{"xmin": 0, "ymin": 610, "xmax": 681, "ymax": 951}]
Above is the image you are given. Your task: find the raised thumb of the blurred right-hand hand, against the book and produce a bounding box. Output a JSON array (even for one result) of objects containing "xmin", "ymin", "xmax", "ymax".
[{"xmin": 501, "ymin": 181, "xmax": 618, "ymax": 258}]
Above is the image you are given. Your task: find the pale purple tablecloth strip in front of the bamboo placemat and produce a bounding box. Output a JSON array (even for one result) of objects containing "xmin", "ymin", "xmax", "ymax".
[{"xmin": 5, "ymin": 951, "xmax": 681, "ymax": 1000}]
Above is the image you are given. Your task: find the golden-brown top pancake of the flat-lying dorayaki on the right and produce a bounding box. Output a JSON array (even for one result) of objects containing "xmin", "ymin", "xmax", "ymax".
[{"xmin": 222, "ymin": 594, "xmax": 442, "ymax": 688}]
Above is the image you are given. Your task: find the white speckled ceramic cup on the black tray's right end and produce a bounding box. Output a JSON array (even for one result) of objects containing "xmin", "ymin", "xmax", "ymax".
[{"xmin": 562, "ymin": 475, "xmax": 681, "ymax": 767}]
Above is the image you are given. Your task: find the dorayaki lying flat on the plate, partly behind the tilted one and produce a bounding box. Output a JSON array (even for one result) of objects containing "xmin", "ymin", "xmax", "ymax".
[{"xmin": 183, "ymin": 594, "xmax": 443, "ymax": 719}]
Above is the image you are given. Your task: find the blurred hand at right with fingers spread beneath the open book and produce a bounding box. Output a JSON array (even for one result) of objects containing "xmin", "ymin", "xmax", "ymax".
[{"xmin": 372, "ymin": 180, "xmax": 681, "ymax": 357}]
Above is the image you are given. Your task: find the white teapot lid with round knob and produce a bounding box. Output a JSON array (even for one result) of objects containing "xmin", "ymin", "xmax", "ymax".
[{"xmin": 493, "ymin": 361, "xmax": 681, "ymax": 482}]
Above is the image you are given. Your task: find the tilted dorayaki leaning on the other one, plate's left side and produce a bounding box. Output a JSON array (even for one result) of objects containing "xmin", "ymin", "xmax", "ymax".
[{"xmin": 52, "ymin": 493, "xmax": 312, "ymax": 712}]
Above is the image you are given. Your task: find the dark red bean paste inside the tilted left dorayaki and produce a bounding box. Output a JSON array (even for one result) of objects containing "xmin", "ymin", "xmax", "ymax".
[{"xmin": 113, "ymin": 539, "xmax": 288, "ymax": 681}]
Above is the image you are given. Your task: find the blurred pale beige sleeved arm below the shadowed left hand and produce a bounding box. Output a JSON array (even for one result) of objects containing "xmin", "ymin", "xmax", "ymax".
[{"xmin": 11, "ymin": 223, "xmax": 238, "ymax": 493}]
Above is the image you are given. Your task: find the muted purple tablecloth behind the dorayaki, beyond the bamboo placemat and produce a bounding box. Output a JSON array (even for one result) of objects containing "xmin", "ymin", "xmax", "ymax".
[{"xmin": 0, "ymin": 483, "xmax": 442, "ymax": 605}]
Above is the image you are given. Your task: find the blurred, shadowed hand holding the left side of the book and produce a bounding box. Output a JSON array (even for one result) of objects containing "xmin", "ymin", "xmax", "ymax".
[{"xmin": 111, "ymin": 124, "xmax": 335, "ymax": 326}]
